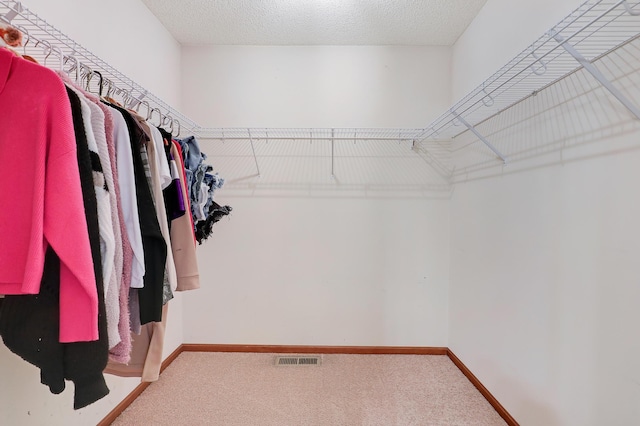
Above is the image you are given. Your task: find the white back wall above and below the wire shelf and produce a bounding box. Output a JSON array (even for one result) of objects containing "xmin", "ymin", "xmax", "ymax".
[{"xmin": 182, "ymin": 46, "xmax": 451, "ymax": 346}]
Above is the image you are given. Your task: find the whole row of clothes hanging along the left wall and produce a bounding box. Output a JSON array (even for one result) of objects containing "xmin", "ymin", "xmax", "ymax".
[{"xmin": 0, "ymin": 35, "xmax": 218, "ymax": 409}]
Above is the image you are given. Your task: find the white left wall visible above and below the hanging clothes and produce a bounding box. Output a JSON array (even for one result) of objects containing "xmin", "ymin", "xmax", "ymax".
[{"xmin": 0, "ymin": 0, "xmax": 182, "ymax": 425}]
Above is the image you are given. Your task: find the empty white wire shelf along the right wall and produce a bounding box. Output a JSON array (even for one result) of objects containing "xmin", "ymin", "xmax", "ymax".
[{"xmin": 419, "ymin": 0, "xmax": 640, "ymax": 146}]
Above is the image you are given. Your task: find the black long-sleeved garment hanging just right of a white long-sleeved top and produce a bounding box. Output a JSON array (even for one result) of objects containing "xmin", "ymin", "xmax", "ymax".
[{"xmin": 109, "ymin": 104, "xmax": 167, "ymax": 324}]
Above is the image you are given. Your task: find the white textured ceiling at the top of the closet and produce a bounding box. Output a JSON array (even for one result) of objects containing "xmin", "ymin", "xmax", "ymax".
[{"xmin": 142, "ymin": 0, "xmax": 487, "ymax": 46}]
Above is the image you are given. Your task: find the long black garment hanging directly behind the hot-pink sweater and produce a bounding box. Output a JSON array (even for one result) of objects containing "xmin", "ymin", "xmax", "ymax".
[{"xmin": 0, "ymin": 89, "xmax": 109, "ymax": 409}]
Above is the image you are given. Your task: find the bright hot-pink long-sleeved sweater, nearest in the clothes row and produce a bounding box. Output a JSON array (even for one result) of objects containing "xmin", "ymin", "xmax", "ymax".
[{"xmin": 0, "ymin": 48, "xmax": 98, "ymax": 343}]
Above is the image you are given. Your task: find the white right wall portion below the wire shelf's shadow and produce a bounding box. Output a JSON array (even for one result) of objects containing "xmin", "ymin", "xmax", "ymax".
[{"xmin": 450, "ymin": 144, "xmax": 640, "ymax": 426}]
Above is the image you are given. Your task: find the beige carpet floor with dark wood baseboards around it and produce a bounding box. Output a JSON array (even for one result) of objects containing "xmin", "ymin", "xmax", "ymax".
[{"xmin": 113, "ymin": 352, "xmax": 505, "ymax": 426}]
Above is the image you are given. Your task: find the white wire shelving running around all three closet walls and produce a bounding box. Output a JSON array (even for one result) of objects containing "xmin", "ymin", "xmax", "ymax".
[{"xmin": 0, "ymin": 0, "xmax": 640, "ymax": 176}]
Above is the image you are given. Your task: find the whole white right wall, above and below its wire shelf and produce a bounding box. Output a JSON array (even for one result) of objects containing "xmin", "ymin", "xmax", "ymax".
[{"xmin": 449, "ymin": 0, "xmax": 640, "ymax": 426}]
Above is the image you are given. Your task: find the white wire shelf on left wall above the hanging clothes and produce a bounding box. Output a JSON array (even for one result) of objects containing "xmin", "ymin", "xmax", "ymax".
[{"xmin": 0, "ymin": 0, "xmax": 200, "ymax": 134}]
